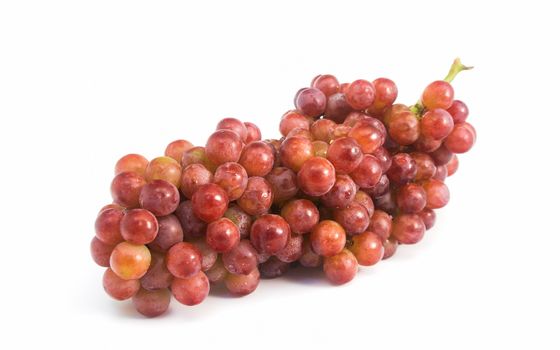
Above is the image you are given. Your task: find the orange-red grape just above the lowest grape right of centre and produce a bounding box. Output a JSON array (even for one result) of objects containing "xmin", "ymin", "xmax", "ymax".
[{"xmin": 310, "ymin": 220, "xmax": 346, "ymax": 256}]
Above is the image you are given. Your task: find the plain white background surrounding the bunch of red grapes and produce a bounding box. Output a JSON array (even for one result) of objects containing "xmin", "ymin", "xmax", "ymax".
[{"xmin": 0, "ymin": 0, "xmax": 560, "ymax": 349}]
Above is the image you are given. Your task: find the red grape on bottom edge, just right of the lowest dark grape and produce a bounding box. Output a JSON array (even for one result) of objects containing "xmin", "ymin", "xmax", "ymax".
[{"xmin": 171, "ymin": 271, "xmax": 210, "ymax": 306}]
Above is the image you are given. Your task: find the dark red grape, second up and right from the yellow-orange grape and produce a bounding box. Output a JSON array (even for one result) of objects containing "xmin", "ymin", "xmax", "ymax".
[{"xmin": 140, "ymin": 180, "xmax": 181, "ymax": 216}]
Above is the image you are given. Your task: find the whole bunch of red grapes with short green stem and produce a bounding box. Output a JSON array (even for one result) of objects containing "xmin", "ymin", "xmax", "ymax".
[{"xmin": 91, "ymin": 61, "xmax": 476, "ymax": 317}]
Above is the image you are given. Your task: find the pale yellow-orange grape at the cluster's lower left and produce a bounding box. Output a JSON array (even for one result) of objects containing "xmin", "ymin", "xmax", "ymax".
[{"xmin": 109, "ymin": 242, "xmax": 151, "ymax": 280}]
